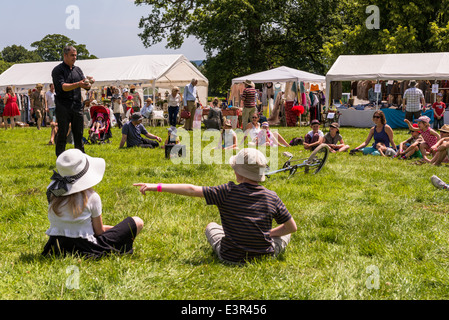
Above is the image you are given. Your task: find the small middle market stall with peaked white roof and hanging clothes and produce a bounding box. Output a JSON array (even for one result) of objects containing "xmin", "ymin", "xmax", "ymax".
[{"xmin": 228, "ymin": 66, "xmax": 325, "ymax": 126}]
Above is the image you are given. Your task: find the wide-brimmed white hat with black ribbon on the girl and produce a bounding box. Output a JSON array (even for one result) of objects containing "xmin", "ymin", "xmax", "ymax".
[{"xmin": 47, "ymin": 149, "xmax": 106, "ymax": 199}]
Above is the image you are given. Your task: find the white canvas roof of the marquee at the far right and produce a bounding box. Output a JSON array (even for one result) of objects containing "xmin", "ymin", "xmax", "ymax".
[{"xmin": 326, "ymin": 52, "xmax": 449, "ymax": 106}]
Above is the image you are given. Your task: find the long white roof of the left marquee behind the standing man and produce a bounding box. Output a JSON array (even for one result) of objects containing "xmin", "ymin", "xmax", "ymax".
[{"xmin": 0, "ymin": 55, "xmax": 209, "ymax": 90}]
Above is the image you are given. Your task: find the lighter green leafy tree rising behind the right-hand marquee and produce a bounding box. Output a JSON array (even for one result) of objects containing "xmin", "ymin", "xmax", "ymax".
[{"xmin": 322, "ymin": 0, "xmax": 449, "ymax": 69}]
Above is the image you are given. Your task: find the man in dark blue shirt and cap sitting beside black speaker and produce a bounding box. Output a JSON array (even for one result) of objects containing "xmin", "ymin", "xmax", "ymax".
[{"xmin": 120, "ymin": 112, "xmax": 162, "ymax": 149}]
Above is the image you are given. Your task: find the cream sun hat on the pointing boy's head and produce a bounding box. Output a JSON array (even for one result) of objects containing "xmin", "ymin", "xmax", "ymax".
[{"xmin": 229, "ymin": 148, "xmax": 267, "ymax": 181}]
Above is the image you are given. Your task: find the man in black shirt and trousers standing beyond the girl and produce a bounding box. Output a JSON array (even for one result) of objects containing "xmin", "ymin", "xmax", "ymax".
[{"xmin": 51, "ymin": 46, "xmax": 94, "ymax": 156}]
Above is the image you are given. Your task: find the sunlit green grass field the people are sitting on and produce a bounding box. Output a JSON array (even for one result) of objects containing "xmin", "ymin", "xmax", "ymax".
[{"xmin": 0, "ymin": 127, "xmax": 449, "ymax": 300}]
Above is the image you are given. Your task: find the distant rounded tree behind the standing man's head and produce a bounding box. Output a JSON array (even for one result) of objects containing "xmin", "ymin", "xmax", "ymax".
[{"xmin": 31, "ymin": 34, "xmax": 97, "ymax": 61}]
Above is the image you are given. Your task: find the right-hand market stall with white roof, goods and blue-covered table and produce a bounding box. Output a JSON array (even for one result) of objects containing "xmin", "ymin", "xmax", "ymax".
[{"xmin": 326, "ymin": 52, "xmax": 449, "ymax": 127}]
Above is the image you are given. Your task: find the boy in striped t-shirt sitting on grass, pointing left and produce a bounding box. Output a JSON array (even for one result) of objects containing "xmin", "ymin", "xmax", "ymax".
[{"xmin": 134, "ymin": 148, "xmax": 297, "ymax": 264}]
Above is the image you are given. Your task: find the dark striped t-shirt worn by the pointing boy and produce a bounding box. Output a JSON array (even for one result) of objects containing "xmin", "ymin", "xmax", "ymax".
[{"xmin": 203, "ymin": 181, "xmax": 292, "ymax": 262}]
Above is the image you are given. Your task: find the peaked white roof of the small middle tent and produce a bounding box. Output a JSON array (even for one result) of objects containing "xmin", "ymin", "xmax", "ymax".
[{"xmin": 232, "ymin": 66, "xmax": 326, "ymax": 84}]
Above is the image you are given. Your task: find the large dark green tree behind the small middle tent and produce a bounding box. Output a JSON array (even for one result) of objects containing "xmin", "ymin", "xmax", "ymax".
[{"xmin": 135, "ymin": 0, "xmax": 338, "ymax": 92}]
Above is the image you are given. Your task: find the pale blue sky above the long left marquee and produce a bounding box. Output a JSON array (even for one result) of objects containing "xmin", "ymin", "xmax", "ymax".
[{"xmin": 0, "ymin": 0, "xmax": 206, "ymax": 60}]
